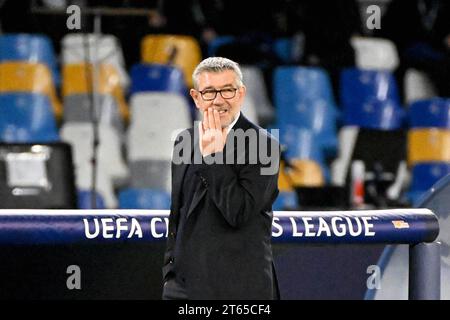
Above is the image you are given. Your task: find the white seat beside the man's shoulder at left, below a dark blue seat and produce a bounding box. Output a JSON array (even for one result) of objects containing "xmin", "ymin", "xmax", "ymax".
[{"xmin": 127, "ymin": 93, "xmax": 192, "ymax": 161}]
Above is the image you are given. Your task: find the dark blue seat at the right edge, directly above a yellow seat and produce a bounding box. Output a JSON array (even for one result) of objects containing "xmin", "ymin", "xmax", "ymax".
[{"xmin": 409, "ymin": 98, "xmax": 450, "ymax": 129}]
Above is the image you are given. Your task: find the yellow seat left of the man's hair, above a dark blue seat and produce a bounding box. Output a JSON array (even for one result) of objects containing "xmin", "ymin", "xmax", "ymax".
[{"xmin": 141, "ymin": 35, "xmax": 202, "ymax": 87}]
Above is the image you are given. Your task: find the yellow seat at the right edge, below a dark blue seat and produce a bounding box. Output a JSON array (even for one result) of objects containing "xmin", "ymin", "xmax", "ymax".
[{"xmin": 408, "ymin": 128, "xmax": 450, "ymax": 166}]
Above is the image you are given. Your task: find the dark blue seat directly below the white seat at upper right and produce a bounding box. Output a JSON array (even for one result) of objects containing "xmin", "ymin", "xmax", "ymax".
[{"xmin": 340, "ymin": 68, "xmax": 404, "ymax": 130}]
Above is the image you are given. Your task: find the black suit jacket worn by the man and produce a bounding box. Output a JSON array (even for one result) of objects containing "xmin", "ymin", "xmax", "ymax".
[{"xmin": 163, "ymin": 114, "xmax": 279, "ymax": 299}]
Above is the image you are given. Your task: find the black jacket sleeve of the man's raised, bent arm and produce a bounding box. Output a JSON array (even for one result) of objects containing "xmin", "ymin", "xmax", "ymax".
[{"xmin": 198, "ymin": 140, "xmax": 279, "ymax": 228}]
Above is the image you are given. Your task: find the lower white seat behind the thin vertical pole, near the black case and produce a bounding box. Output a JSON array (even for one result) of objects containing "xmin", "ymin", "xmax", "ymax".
[{"xmin": 61, "ymin": 122, "xmax": 128, "ymax": 189}]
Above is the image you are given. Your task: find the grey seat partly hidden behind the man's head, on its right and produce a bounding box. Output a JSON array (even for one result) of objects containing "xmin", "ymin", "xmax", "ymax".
[{"xmin": 241, "ymin": 65, "xmax": 275, "ymax": 126}]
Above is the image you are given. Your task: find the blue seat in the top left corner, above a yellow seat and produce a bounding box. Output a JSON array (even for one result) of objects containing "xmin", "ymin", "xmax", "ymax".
[{"xmin": 0, "ymin": 34, "xmax": 61, "ymax": 86}]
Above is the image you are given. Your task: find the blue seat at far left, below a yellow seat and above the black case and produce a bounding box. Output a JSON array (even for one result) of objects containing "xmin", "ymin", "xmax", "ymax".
[{"xmin": 0, "ymin": 93, "xmax": 59, "ymax": 143}]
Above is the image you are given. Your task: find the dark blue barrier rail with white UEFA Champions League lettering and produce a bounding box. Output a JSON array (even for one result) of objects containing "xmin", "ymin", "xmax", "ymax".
[{"xmin": 0, "ymin": 209, "xmax": 440, "ymax": 299}]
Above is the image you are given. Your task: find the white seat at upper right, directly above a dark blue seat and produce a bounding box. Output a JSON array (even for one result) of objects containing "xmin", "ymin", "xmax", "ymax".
[{"xmin": 350, "ymin": 37, "xmax": 399, "ymax": 71}]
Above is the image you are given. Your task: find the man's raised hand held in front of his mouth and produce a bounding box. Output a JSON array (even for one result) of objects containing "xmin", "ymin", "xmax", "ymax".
[{"xmin": 198, "ymin": 108, "xmax": 227, "ymax": 157}]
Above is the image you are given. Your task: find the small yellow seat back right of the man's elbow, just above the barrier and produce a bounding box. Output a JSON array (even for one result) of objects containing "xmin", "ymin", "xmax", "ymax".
[{"xmin": 287, "ymin": 160, "xmax": 325, "ymax": 187}]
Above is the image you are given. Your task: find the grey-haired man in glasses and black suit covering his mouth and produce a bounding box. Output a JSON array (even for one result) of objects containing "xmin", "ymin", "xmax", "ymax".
[{"xmin": 163, "ymin": 57, "xmax": 279, "ymax": 299}]
